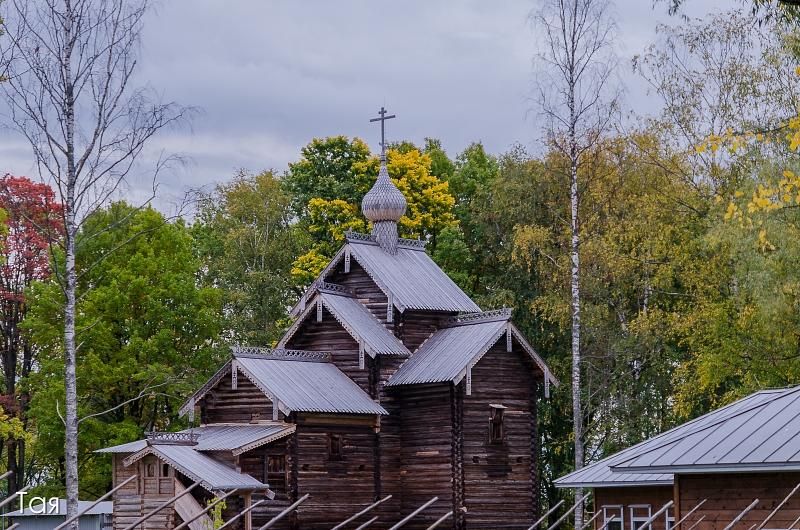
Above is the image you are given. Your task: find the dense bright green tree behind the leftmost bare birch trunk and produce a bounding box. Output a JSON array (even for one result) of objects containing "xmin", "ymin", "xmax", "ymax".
[{"xmin": 23, "ymin": 203, "xmax": 222, "ymax": 497}]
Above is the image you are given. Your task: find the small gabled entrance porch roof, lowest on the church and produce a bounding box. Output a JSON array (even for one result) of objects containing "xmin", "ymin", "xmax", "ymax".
[{"xmin": 124, "ymin": 445, "xmax": 268, "ymax": 492}]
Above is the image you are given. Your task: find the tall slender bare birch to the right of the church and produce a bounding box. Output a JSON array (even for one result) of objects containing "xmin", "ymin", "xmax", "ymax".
[{"xmin": 533, "ymin": 0, "xmax": 617, "ymax": 528}]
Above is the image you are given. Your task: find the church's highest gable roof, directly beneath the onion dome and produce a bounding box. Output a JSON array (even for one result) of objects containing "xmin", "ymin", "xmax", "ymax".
[{"xmin": 292, "ymin": 232, "xmax": 481, "ymax": 316}]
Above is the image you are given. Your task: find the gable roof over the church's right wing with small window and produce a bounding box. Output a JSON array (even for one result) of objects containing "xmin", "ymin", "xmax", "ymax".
[{"xmin": 386, "ymin": 309, "xmax": 558, "ymax": 386}]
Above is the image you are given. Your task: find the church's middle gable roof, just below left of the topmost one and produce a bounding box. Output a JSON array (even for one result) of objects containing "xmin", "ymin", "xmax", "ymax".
[{"xmin": 278, "ymin": 284, "xmax": 411, "ymax": 357}]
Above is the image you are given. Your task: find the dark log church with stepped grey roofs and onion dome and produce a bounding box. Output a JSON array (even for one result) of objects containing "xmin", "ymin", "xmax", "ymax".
[{"xmin": 103, "ymin": 111, "xmax": 556, "ymax": 530}]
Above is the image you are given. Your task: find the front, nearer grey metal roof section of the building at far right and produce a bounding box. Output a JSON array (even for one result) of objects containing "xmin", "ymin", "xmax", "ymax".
[{"xmin": 611, "ymin": 386, "xmax": 800, "ymax": 473}]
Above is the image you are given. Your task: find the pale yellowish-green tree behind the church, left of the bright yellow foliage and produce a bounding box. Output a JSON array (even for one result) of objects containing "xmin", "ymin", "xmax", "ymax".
[{"xmin": 192, "ymin": 171, "xmax": 304, "ymax": 345}]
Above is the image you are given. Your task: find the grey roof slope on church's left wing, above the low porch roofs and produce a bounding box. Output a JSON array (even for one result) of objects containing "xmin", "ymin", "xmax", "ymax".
[{"xmin": 234, "ymin": 348, "xmax": 388, "ymax": 414}]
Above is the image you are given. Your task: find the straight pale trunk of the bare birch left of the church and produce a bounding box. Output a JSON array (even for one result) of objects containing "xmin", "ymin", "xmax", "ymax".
[{"xmin": 62, "ymin": 0, "xmax": 78, "ymax": 520}]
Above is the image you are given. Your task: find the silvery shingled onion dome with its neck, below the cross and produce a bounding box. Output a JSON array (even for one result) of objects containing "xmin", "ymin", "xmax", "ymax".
[{"xmin": 361, "ymin": 156, "xmax": 406, "ymax": 254}]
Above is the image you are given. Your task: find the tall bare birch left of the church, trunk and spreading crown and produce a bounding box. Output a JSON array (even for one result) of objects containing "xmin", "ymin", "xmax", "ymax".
[{"xmin": 0, "ymin": 0, "xmax": 186, "ymax": 528}]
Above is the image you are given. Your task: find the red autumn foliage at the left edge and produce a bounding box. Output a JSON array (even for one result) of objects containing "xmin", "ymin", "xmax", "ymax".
[{"xmin": 0, "ymin": 175, "xmax": 64, "ymax": 302}]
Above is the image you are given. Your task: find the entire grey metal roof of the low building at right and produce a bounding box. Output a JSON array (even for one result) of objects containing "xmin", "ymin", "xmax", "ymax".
[{"xmin": 555, "ymin": 387, "xmax": 800, "ymax": 488}]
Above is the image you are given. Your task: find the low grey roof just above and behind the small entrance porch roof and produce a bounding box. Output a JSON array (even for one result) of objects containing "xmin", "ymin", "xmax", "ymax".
[{"xmin": 182, "ymin": 422, "xmax": 297, "ymax": 455}]
